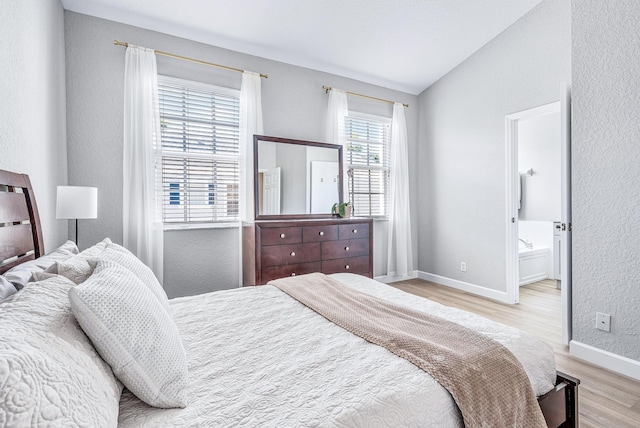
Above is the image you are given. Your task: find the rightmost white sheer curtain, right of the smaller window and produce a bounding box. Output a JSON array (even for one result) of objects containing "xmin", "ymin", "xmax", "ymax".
[{"xmin": 387, "ymin": 103, "xmax": 414, "ymax": 277}]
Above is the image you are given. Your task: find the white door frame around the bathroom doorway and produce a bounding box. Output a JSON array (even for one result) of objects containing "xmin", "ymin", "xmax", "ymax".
[{"xmin": 505, "ymin": 88, "xmax": 571, "ymax": 344}]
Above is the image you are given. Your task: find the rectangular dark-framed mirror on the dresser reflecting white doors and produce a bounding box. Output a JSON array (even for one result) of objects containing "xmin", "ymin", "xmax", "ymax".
[{"xmin": 253, "ymin": 135, "xmax": 342, "ymax": 220}]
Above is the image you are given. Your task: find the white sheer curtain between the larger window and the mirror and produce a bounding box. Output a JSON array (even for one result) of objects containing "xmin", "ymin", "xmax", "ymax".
[{"xmin": 240, "ymin": 71, "xmax": 264, "ymax": 222}]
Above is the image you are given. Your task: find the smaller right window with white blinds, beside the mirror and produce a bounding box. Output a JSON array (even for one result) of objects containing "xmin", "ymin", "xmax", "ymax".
[{"xmin": 344, "ymin": 112, "xmax": 391, "ymax": 217}]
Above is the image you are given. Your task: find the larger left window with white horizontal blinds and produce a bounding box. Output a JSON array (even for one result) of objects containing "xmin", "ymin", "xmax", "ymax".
[{"xmin": 158, "ymin": 76, "xmax": 240, "ymax": 223}]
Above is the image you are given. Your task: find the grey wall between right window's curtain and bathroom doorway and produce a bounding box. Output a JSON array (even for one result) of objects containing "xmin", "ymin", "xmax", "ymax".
[{"xmin": 418, "ymin": 0, "xmax": 571, "ymax": 291}]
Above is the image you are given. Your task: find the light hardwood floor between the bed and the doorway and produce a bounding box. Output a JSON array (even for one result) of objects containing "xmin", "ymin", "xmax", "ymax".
[{"xmin": 389, "ymin": 279, "xmax": 640, "ymax": 428}]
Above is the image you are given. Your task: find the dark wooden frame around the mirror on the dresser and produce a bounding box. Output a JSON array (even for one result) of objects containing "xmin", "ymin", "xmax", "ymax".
[{"xmin": 253, "ymin": 135, "xmax": 344, "ymax": 220}]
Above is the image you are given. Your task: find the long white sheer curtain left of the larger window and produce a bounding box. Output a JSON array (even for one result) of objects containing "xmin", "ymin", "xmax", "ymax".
[{"xmin": 122, "ymin": 45, "xmax": 164, "ymax": 284}]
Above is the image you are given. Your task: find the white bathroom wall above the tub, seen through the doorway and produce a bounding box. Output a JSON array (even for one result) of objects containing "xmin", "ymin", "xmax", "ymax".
[{"xmin": 518, "ymin": 112, "xmax": 562, "ymax": 222}]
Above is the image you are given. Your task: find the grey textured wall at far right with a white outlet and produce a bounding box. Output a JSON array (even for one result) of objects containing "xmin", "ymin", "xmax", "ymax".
[{"xmin": 572, "ymin": 0, "xmax": 640, "ymax": 361}]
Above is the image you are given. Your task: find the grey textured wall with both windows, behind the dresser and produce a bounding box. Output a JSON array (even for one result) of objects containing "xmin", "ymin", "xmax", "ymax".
[{"xmin": 65, "ymin": 11, "xmax": 418, "ymax": 294}]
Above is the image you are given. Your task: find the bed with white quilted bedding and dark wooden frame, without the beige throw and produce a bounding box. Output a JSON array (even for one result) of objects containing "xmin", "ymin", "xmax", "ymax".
[{"xmin": 0, "ymin": 171, "xmax": 579, "ymax": 427}]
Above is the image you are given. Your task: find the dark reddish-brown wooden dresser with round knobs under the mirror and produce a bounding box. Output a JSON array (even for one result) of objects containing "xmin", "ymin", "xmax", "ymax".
[{"xmin": 242, "ymin": 218, "xmax": 373, "ymax": 286}]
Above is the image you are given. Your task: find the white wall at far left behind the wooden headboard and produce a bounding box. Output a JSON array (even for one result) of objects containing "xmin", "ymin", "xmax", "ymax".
[{"xmin": 0, "ymin": 0, "xmax": 67, "ymax": 251}]
